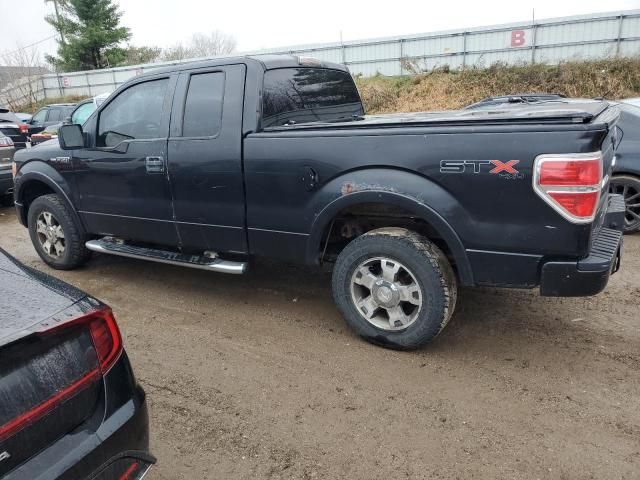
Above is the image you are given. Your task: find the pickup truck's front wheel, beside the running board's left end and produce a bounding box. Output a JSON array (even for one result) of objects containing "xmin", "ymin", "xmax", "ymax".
[{"xmin": 28, "ymin": 194, "xmax": 91, "ymax": 270}]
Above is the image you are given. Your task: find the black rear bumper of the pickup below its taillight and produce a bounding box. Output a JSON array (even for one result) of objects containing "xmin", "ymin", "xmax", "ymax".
[{"xmin": 540, "ymin": 195, "xmax": 625, "ymax": 297}]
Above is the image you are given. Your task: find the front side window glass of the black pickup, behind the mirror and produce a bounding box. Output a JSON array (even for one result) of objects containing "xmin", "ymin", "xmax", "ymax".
[{"xmin": 96, "ymin": 78, "xmax": 169, "ymax": 147}]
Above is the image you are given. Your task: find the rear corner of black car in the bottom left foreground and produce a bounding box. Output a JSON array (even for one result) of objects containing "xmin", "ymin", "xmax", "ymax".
[{"xmin": 0, "ymin": 248, "xmax": 155, "ymax": 480}]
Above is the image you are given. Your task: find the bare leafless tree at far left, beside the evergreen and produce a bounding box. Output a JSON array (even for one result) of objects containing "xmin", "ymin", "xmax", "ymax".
[{"xmin": 0, "ymin": 46, "xmax": 48, "ymax": 109}]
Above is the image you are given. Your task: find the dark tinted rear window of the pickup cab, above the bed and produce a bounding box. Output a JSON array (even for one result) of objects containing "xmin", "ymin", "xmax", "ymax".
[{"xmin": 262, "ymin": 68, "xmax": 364, "ymax": 128}]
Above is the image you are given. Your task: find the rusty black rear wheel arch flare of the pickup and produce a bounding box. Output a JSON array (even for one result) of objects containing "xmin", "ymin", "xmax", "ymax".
[{"xmin": 306, "ymin": 168, "xmax": 473, "ymax": 285}]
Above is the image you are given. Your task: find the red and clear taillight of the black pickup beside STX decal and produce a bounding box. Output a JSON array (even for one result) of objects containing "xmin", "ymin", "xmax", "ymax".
[{"xmin": 533, "ymin": 152, "xmax": 603, "ymax": 223}]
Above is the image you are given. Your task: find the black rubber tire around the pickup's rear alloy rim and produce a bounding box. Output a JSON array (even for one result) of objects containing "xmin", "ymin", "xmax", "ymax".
[{"xmin": 332, "ymin": 228, "xmax": 457, "ymax": 350}]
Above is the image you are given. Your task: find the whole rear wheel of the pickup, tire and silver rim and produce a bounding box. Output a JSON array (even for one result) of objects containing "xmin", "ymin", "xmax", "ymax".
[{"xmin": 333, "ymin": 228, "xmax": 457, "ymax": 350}]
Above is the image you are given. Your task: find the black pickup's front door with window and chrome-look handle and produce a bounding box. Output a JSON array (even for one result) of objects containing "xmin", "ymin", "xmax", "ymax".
[{"xmin": 73, "ymin": 76, "xmax": 179, "ymax": 246}]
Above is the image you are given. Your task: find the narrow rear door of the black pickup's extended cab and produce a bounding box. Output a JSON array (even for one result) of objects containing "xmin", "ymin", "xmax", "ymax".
[{"xmin": 168, "ymin": 65, "xmax": 247, "ymax": 253}]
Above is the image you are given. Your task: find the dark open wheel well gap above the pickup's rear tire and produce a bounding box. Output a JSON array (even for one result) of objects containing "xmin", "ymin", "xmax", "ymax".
[{"xmin": 318, "ymin": 203, "xmax": 455, "ymax": 269}]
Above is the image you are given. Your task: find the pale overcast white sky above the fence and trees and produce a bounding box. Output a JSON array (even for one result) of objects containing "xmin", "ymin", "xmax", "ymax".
[{"xmin": 0, "ymin": 0, "xmax": 640, "ymax": 58}]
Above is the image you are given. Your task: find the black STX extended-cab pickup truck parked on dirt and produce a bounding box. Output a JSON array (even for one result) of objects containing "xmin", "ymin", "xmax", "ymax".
[{"xmin": 15, "ymin": 56, "xmax": 624, "ymax": 349}]
